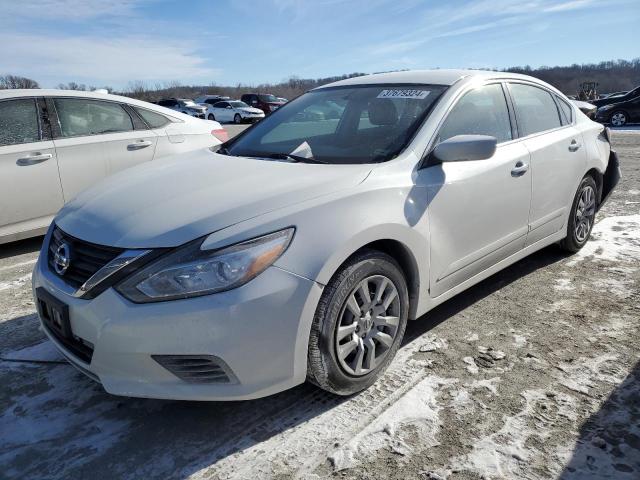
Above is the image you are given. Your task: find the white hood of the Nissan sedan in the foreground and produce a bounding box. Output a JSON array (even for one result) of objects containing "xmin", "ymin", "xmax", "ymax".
[{"xmin": 55, "ymin": 150, "xmax": 371, "ymax": 248}]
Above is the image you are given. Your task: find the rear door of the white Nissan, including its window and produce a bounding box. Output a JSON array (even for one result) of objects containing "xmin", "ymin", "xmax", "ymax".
[{"xmin": 509, "ymin": 82, "xmax": 586, "ymax": 245}]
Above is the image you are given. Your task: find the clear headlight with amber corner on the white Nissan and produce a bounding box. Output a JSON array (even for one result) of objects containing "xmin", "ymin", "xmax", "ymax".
[{"xmin": 116, "ymin": 227, "xmax": 295, "ymax": 303}]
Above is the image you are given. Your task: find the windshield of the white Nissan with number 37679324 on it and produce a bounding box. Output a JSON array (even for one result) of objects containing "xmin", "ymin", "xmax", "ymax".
[{"xmin": 228, "ymin": 84, "xmax": 446, "ymax": 164}]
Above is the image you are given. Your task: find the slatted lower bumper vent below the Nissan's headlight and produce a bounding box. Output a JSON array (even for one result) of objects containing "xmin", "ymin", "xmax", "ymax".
[{"xmin": 151, "ymin": 355, "xmax": 237, "ymax": 383}]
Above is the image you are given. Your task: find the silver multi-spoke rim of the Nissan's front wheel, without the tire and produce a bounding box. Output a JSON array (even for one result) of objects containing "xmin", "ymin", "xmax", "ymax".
[{"xmin": 335, "ymin": 275, "xmax": 401, "ymax": 376}]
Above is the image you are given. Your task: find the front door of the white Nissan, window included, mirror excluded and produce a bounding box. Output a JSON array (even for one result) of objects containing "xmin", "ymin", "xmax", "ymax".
[{"xmin": 418, "ymin": 83, "xmax": 531, "ymax": 298}]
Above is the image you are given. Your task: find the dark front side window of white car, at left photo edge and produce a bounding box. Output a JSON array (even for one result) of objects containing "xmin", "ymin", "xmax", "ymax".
[{"xmin": 0, "ymin": 98, "xmax": 40, "ymax": 146}]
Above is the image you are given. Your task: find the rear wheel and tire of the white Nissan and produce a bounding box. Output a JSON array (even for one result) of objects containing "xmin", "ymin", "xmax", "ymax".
[{"xmin": 560, "ymin": 175, "xmax": 598, "ymax": 253}]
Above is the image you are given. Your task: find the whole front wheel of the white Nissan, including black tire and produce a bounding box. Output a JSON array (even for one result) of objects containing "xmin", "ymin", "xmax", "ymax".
[{"xmin": 307, "ymin": 250, "xmax": 409, "ymax": 395}]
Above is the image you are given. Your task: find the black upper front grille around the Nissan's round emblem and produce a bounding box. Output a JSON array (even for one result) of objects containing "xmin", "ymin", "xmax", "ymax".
[{"xmin": 48, "ymin": 226, "xmax": 124, "ymax": 288}]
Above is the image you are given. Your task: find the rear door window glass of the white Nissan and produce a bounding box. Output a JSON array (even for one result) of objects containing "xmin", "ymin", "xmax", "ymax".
[{"xmin": 509, "ymin": 83, "xmax": 561, "ymax": 137}]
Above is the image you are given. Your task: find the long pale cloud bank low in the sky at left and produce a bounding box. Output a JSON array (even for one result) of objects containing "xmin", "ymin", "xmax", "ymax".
[{"xmin": 0, "ymin": 33, "xmax": 220, "ymax": 86}]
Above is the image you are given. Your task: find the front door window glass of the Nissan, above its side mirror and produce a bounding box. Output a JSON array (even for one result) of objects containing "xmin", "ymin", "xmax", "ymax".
[{"xmin": 439, "ymin": 83, "xmax": 513, "ymax": 143}]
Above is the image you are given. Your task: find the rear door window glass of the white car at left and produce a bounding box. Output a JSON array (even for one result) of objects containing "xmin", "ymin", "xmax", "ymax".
[{"xmin": 53, "ymin": 98, "xmax": 133, "ymax": 137}]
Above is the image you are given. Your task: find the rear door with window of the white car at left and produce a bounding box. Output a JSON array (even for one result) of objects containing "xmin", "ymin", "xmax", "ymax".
[{"xmin": 49, "ymin": 97, "xmax": 157, "ymax": 201}]
